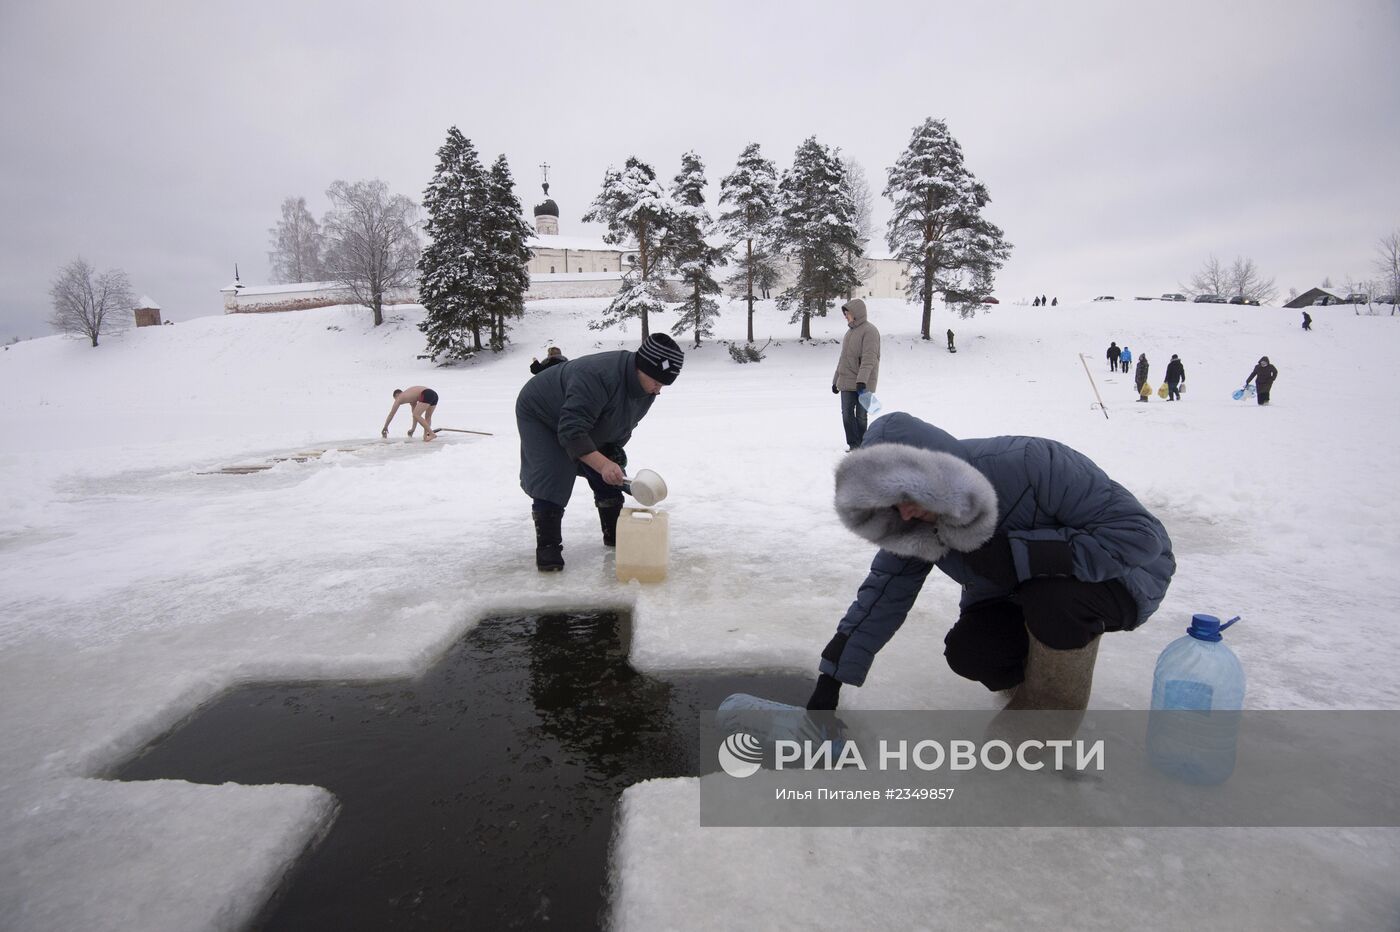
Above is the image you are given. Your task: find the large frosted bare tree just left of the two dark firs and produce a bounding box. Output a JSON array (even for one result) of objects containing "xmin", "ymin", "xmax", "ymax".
[{"xmin": 322, "ymin": 179, "xmax": 420, "ymax": 326}]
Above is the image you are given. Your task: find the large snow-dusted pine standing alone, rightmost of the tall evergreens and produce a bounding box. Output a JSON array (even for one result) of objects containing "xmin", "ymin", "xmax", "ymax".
[{"xmin": 885, "ymin": 118, "xmax": 1011, "ymax": 334}]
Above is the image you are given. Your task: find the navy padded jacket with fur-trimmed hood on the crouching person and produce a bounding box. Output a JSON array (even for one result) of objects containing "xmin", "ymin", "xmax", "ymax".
[{"xmin": 820, "ymin": 413, "xmax": 1176, "ymax": 686}]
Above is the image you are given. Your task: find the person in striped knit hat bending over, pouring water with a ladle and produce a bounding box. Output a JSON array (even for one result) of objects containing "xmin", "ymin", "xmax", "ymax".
[{"xmin": 515, "ymin": 333, "xmax": 685, "ymax": 572}]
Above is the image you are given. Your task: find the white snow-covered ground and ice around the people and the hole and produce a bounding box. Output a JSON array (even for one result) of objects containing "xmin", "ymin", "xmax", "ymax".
[{"xmin": 0, "ymin": 299, "xmax": 1400, "ymax": 931}]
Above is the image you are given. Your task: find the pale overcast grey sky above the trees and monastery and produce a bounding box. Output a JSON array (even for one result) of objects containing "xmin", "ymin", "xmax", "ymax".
[{"xmin": 0, "ymin": 0, "xmax": 1400, "ymax": 335}]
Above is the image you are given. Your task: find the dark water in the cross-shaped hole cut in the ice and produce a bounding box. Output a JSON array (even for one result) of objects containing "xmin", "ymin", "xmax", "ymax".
[{"xmin": 113, "ymin": 613, "xmax": 811, "ymax": 931}]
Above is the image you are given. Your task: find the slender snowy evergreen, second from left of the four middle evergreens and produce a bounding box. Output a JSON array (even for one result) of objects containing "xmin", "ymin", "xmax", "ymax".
[{"xmin": 665, "ymin": 153, "xmax": 725, "ymax": 347}]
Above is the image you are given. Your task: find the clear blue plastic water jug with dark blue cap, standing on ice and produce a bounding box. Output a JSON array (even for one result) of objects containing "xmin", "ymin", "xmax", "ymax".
[{"xmin": 1147, "ymin": 614, "xmax": 1245, "ymax": 785}]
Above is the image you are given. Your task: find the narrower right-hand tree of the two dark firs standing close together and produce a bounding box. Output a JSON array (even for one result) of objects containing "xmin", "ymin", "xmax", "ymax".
[{"xmin": 482, "ymin": 155, "xmax": 535, "ymax": 353}]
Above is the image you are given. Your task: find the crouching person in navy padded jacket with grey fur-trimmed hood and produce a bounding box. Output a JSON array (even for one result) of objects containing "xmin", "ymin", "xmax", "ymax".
[{"xmin": 808, "ymin": 413, "xmax": 1176, "ymax": 709}]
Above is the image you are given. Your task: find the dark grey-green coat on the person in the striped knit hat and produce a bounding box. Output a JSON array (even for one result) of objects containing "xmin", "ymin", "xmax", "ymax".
[{"xmin": 515, "ymin": 350, "xmax": 657, "ymax": 507}]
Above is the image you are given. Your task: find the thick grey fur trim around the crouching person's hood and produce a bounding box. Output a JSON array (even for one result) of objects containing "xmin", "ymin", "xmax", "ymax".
[{"xmin": 836, "ymin": 444, "xmax": 997, "ymax": 563}]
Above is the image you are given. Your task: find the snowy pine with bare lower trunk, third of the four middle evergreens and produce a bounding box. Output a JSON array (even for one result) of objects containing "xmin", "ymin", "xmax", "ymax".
[{"xmin": 720, "ymin": 143, "xmax": 778, "ymax": 343}]
